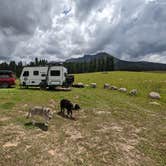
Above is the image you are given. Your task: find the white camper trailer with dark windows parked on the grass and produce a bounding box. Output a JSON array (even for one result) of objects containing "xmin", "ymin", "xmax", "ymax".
[{"xmin": 20, "ymin": 66, "xmax": 74, "ymax": 89}]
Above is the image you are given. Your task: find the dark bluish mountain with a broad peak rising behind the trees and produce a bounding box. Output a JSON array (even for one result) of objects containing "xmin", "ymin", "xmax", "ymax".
[{"xmin": 66, "ymin": 52, "xmax": 166, "ymax": 71}]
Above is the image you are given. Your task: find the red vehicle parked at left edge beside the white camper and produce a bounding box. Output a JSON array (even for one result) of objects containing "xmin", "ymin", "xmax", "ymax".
[{"xmin": 0, "ymin": 70, "xmax": 16, "ymax": 88}]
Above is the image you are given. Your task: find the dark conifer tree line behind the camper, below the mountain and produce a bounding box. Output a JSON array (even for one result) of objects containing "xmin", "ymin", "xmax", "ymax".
[{"xmin": 0, "ymin": 57, "xmax": 114, "ymax": 77}]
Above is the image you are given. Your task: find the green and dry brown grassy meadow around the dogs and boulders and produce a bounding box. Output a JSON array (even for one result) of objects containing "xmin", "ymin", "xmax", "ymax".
[{"xmin": 0, "ymin": 72, "xmax": 166, "ymax": 166}]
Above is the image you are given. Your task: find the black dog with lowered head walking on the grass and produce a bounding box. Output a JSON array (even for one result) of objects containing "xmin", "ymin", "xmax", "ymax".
[{"xmin": 60, "ymin": 99, "xmax": 80, "ymax": 117}]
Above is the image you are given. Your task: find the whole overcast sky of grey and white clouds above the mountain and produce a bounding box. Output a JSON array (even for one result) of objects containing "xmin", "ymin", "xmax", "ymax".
[{"xmin": 0, "ymin": 0, "xmax": 166, "ymax": 63}]
